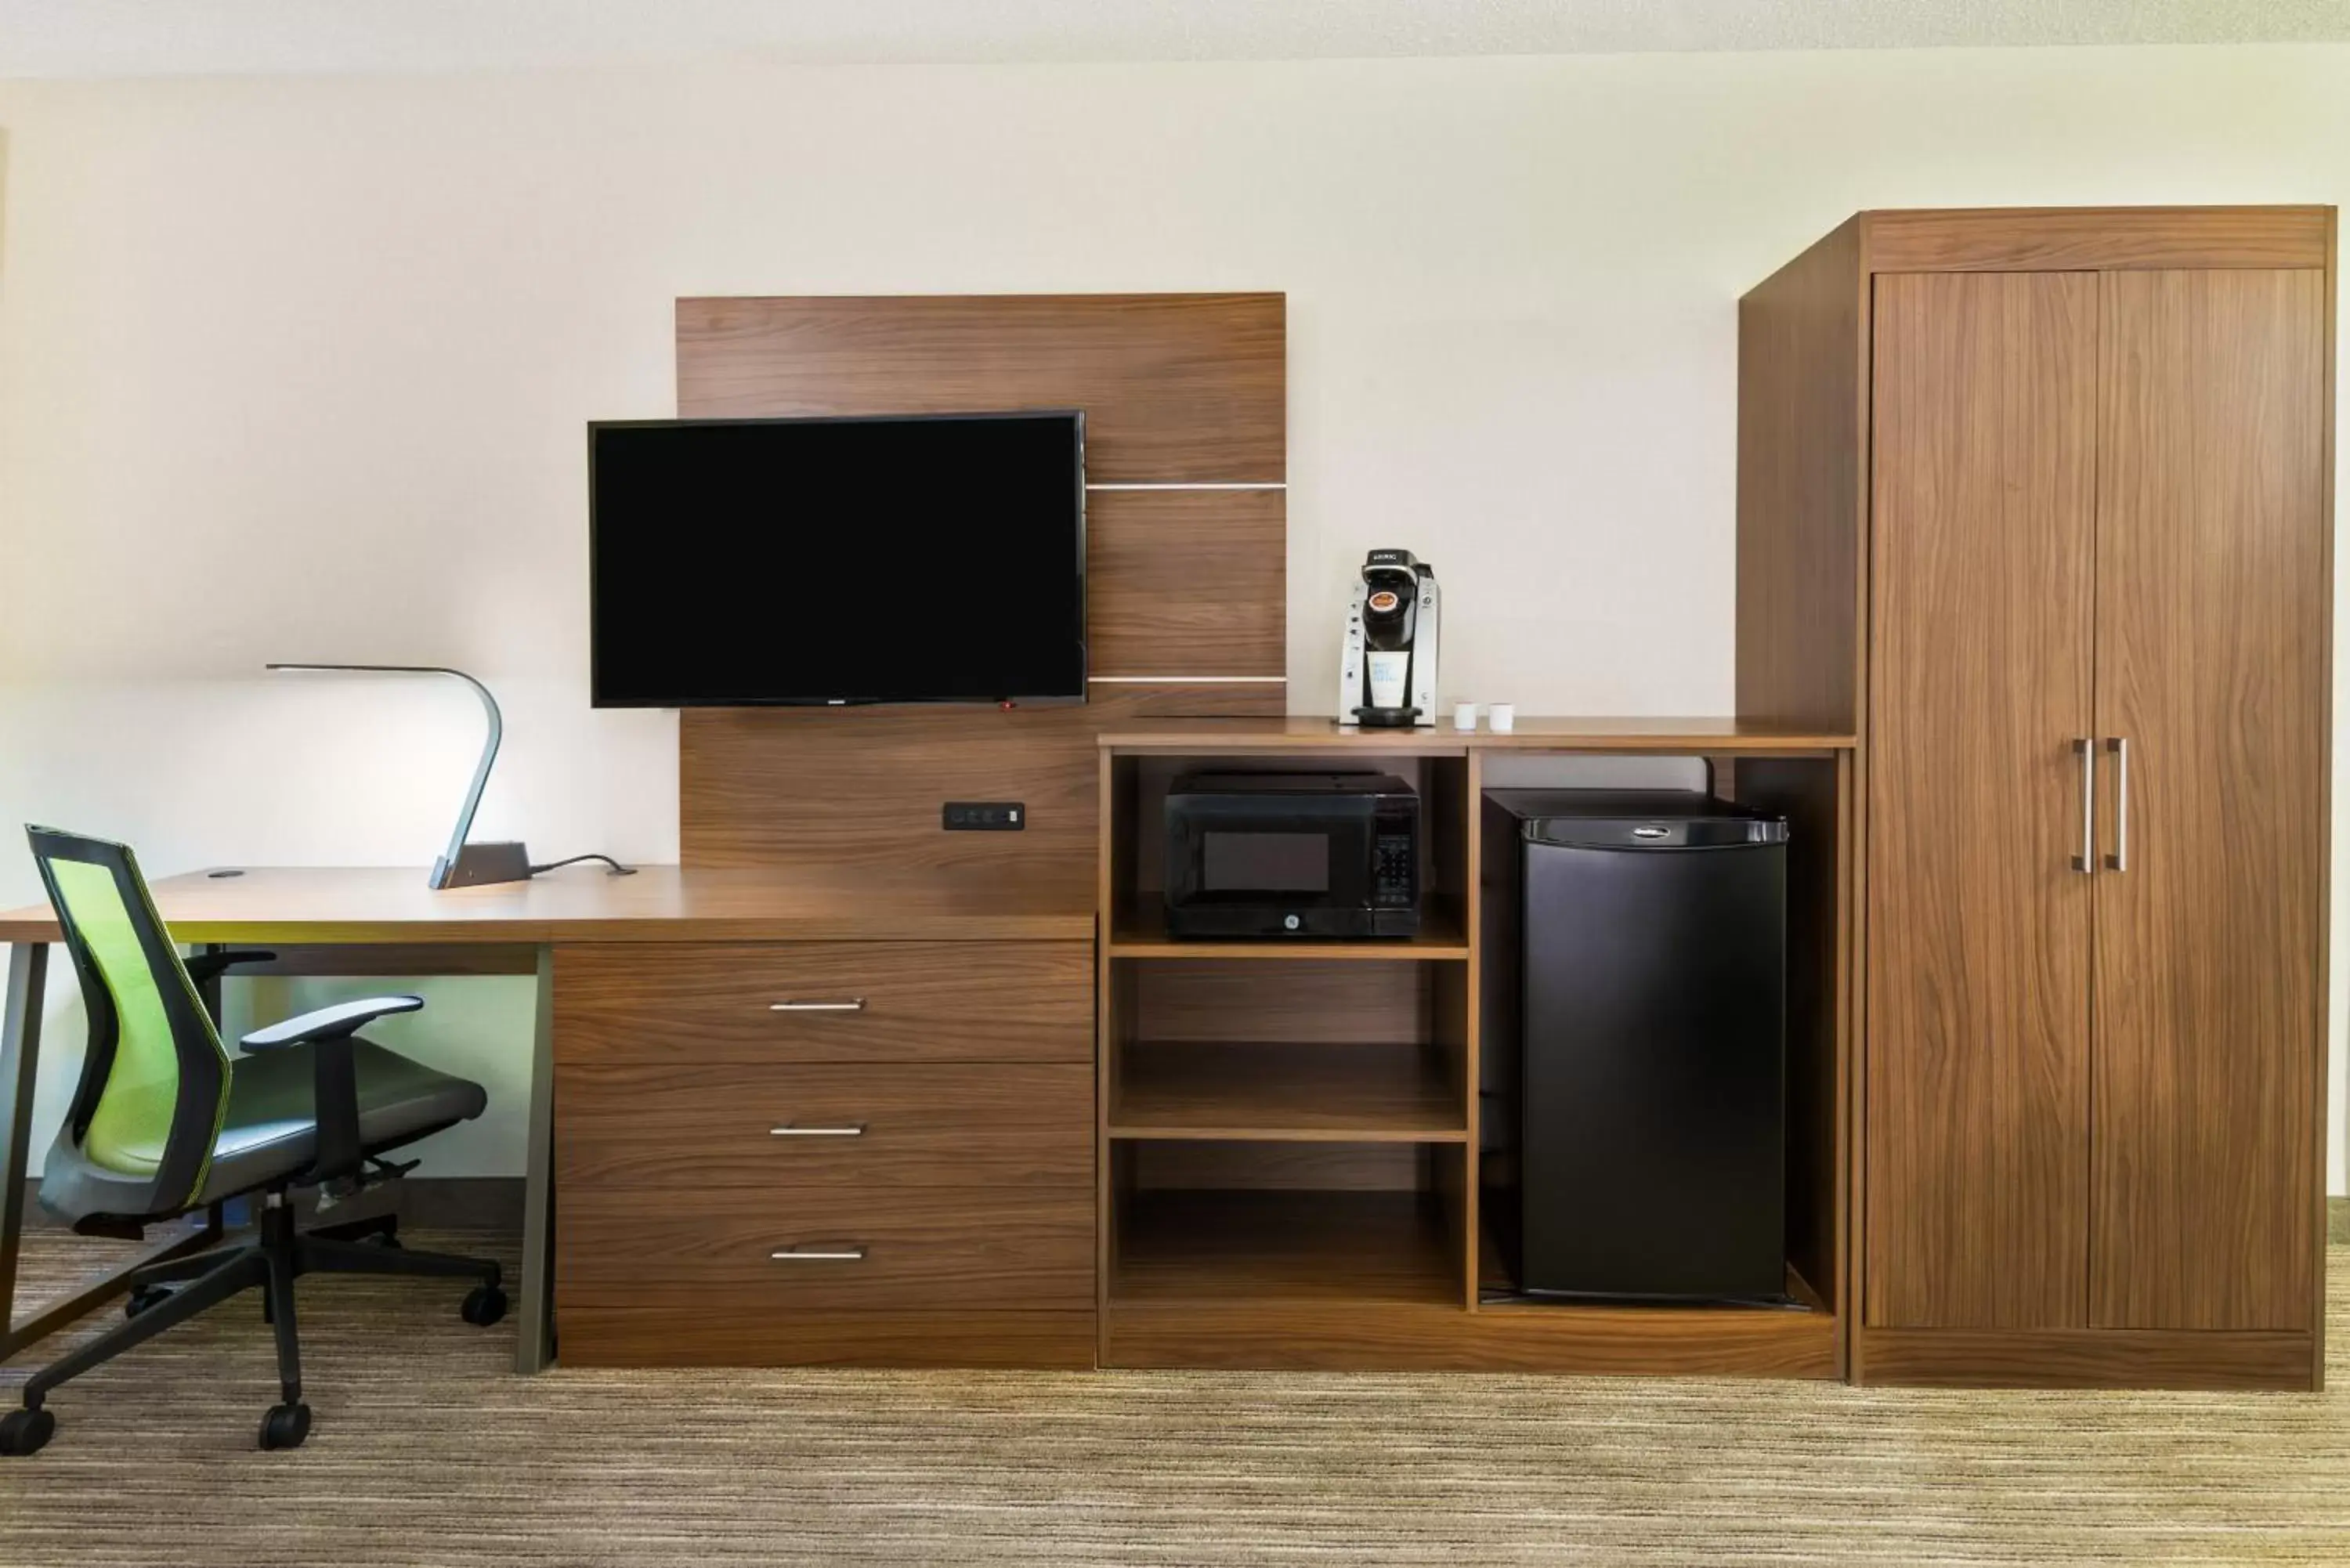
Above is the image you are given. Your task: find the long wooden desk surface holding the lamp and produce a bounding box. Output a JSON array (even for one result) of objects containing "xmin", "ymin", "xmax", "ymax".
[{"xmin": 0, "ymin": 865, "xmax": 1095, "ymax": 945}]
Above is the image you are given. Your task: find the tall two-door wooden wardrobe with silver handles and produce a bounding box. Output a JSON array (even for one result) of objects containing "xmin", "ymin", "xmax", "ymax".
[{"xmin": 1739, "ymin": 207, "xmax": 2334, "ymax": 1387}]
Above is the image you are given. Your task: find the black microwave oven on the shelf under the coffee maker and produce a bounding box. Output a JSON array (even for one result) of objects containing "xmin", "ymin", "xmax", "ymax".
[{"xmin": 1166, "ymin": 773, "xmax": 1419, "ymax": 938}]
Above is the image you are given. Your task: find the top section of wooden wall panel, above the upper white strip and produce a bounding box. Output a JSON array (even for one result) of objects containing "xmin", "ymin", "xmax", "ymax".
[{"xmin": 677, "ymin": 294, "xmax": 1288, "ymax": 484}]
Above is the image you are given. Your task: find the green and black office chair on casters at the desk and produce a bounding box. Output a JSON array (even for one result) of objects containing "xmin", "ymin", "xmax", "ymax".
[{"xmin": 0, "ymin": 828, "xmax": 505, "ymax": 1455}]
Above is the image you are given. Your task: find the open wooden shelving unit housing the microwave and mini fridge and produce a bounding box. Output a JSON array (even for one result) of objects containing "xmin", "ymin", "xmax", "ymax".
[{"xmin": 1097, "ymin": 719, "xmax": 1852, "ymax": 1378}]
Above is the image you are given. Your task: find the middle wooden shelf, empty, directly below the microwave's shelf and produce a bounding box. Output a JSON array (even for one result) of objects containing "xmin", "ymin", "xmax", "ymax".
[{"xmin": 1109, "ymin": 1042, "xmax": 1469, "ymax": 1143}]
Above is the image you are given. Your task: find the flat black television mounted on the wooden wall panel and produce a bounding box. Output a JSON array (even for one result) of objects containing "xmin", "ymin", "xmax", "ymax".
[{"xmin": 588, "ymin": 409, "xmax": 1086, "ymax": 707}]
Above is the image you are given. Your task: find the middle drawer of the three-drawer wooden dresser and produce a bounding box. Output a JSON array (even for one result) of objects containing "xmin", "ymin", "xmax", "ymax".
[{"xmin": 555, "ymin": 1063, "xmax": 1093, "ymax": 1194}]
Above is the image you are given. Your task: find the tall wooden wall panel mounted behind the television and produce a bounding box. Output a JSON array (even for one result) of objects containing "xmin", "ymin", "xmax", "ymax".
[{"xmin": 677, "ymin": 294, "xmax": 1288, "ymax": 883}]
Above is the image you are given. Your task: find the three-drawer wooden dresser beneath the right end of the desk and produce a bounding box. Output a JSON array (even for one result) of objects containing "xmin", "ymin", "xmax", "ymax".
[{"xmin": 555, "ymin": 887, "xmax": 1095, "ymax": 1366}]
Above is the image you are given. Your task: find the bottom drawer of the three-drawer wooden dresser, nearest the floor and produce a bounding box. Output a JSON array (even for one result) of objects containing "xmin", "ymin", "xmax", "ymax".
[{"xmin": 555, "ymin": 1187, "xmax": 1093, "ymax": 1314}]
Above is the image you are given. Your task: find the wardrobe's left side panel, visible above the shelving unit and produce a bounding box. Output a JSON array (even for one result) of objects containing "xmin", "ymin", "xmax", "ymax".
[{"xmin": 1737, "ymin": 219, "xmax": 1868, "ymax": 731}]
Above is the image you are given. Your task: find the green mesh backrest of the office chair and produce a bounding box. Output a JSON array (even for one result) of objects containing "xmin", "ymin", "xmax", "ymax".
[{"xmin": 26, "ymin": 828, "xmax": 228, "ymax": 1220}]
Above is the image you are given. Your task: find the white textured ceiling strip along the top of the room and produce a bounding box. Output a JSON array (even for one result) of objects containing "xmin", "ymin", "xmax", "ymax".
[{"xmin": 0, "ymin": 0, "xmax": 2350, "ymax": 78}]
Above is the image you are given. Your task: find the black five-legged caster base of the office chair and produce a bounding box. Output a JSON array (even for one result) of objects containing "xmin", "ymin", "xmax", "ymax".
[{"xmin": 0, "ymin": 1187, "xmax": 505, "ymax": 1455}]
